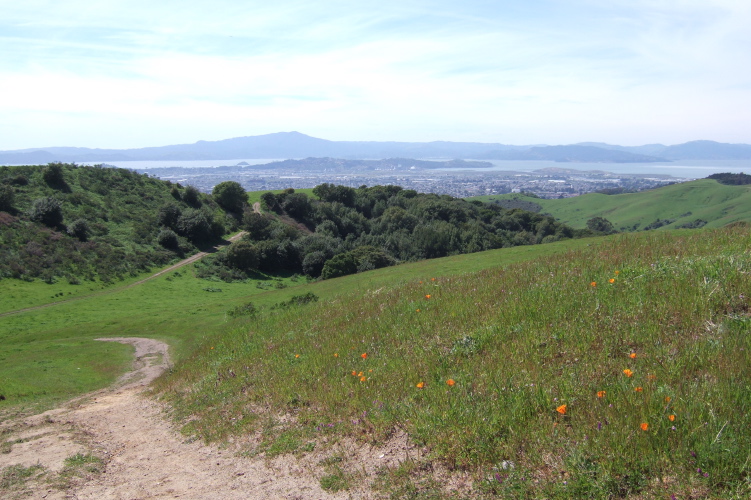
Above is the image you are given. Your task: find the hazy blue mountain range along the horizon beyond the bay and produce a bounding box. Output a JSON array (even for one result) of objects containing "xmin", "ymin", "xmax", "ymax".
[{"xmin": 0, "ymin": 132, "xmax": 751, "ymax": 165}]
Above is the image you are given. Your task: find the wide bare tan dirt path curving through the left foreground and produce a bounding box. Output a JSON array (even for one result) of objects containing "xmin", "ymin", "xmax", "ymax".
[{"xmin": 0, "ymin": 338, "xmax": 356, "ymax": 500}]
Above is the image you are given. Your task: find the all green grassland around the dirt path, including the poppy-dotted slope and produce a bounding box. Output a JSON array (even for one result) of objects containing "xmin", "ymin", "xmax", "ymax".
[{"xmin": 0, "ymin": 201, "xmax": 751, "ymax": 498}]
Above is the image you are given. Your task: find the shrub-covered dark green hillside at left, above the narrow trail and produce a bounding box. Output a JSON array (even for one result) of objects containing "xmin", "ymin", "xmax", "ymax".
[{"xmin": 0, "ymin": 164, "xmax": 233, "ymax": 283}]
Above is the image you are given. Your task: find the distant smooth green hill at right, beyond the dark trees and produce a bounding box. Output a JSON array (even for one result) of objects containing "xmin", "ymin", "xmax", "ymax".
[{"xmin": 472, "ymin": 179, "xmax": 751, "ymax": 229}]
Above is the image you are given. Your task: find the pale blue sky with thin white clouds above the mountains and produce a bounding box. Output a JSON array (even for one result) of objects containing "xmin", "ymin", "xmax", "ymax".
[{"xmin": 0, "ymin": 0, "xmax": 751, "ymax": 150}]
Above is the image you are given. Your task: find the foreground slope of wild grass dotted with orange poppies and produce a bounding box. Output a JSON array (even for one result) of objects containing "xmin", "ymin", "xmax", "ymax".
[{"xmin": 157, "ymin": 227, "xmax": 751, "ymax": 498}]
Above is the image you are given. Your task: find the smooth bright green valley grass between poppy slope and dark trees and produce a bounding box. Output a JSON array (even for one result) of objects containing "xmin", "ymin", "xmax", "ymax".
[{"xmin": 0, "ymin": 236, "xmax": 595, "ymax": 408}]
